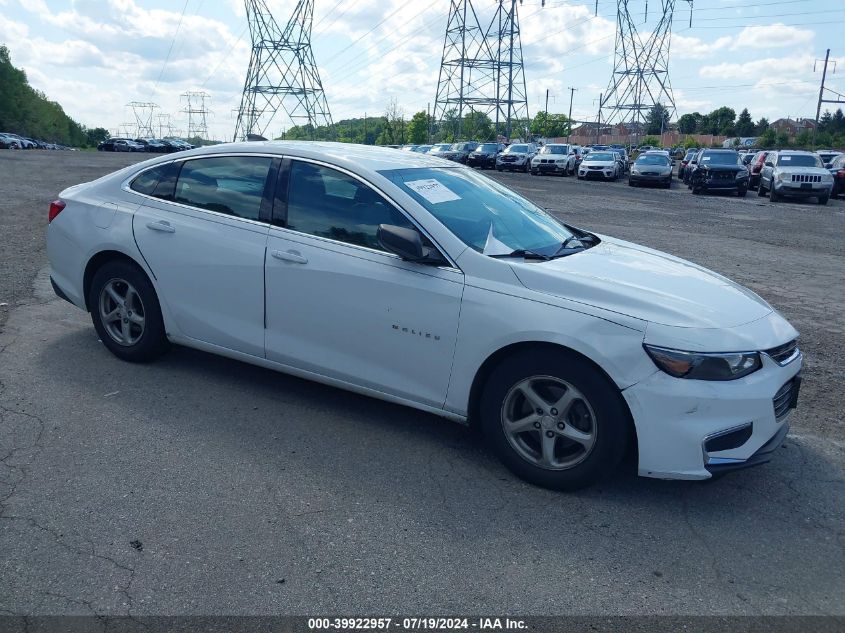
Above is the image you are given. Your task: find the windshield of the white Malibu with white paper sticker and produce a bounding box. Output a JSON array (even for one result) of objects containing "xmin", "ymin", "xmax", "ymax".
[{"xmin": 379, "ymin": 167, "xmax": 573, "ymax": 256}]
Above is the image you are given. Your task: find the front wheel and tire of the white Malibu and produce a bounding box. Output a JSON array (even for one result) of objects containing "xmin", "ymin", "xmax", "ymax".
[{"xmin": 481, "ymin": 350, "xmax": 631, "ymax": 490}]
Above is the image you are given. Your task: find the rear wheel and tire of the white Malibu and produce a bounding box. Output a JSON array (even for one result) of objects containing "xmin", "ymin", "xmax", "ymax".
[{"xmin": 88, "ymin": 261, "xmax": 169, "ymax": 363}]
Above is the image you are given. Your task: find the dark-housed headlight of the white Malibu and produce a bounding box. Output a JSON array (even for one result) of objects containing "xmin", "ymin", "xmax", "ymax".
[{"xmin": 643, "ymin": 344, "xmax": 763, "ymax": 380}]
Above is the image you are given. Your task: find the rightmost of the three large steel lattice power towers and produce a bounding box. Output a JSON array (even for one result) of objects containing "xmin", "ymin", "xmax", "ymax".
[{"xmin": 600, "ymin": 0, "xmax": 693, "ymax": 142}]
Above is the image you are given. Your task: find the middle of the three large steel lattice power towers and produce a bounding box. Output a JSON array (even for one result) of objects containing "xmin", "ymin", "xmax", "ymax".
[{"xmin": 434, "ymin": 0, "xmax": 545, "ymax": 139}]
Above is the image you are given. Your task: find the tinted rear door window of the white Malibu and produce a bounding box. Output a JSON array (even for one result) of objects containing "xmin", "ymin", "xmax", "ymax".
[{"xmin": 174, "ymin": 156, "xmax": 273, "ymax": 220}]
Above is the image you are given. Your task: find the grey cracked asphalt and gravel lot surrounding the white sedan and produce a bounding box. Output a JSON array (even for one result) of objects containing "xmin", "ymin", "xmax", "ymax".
[{"xmin": 0, "ymin": 151, "xmax": 845, "ymax": 616}]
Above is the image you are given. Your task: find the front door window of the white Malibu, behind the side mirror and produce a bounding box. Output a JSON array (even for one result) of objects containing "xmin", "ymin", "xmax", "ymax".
[{"xmin": 287, "ymin": 161, "xmax": 414, "ymax": 250}]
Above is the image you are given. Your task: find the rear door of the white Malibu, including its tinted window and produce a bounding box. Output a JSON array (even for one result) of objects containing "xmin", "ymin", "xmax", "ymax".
[{"xmin": 131, "ymin": 155, "xmax": 279, "ymax": 357}]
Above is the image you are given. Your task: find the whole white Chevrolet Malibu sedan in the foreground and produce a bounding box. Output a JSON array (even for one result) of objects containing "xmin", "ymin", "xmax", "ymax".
[{"xmin": 47, "ymin": 142, "xmax": 802, "ymax": 490}]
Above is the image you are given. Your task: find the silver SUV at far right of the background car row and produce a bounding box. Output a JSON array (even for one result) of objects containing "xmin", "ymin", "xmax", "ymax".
[{"xmin": 757, "ymin": 150, "xmax": 833, "ymax": 204}]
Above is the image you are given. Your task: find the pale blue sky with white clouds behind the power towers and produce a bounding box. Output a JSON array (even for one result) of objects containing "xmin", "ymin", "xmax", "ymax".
[{"xmin": 0, "ymin": 0, "xmax": 845, "ymax": 140}]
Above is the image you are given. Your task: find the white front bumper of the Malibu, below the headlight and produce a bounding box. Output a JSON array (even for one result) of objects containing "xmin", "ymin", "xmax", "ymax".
[{"xmin": 622, "ymin": 354, "xmax": 803, "ymax": 479}]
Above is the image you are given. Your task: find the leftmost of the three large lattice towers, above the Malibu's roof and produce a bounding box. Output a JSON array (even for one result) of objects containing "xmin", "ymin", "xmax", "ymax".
[{"xmin": 234, "ymin": 0, "xmax": 333, "ymax": 140}]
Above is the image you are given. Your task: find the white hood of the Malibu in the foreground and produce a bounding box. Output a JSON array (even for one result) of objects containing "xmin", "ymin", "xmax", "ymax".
[{"xmin": 512, "ymin": 236, "xmax": 772, "ymax": 328}]
